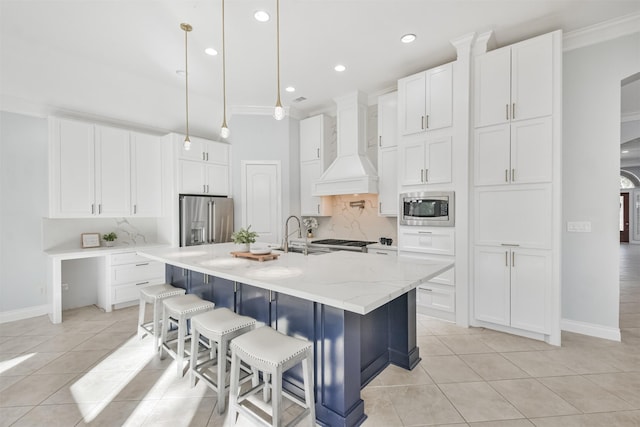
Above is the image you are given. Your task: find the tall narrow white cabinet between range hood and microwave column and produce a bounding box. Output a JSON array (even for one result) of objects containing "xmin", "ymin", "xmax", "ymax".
[{"xmin": 378, "ymin": 92, "xmax": 398, "ymax": 216}]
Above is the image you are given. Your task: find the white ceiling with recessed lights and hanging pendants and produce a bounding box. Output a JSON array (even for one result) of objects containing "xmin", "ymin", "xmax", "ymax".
[{"xmin": 0, "ymin": 0, "xmax": 640, "ymax": 144}]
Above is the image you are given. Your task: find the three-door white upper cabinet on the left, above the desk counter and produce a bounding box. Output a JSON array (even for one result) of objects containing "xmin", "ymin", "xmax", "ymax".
[{"xmin": 49, "ymin": 118, "xmax": 162, "ymax": 218}]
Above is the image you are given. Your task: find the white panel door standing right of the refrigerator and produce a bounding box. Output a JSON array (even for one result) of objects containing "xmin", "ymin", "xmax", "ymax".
[{"xmin": 242, "ymin": 161, "xmax": 283, "ymax": 243}]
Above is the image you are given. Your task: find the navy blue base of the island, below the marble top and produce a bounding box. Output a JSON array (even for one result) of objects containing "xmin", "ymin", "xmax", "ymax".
[{"xmin": 166, "ymin": 264, "xmax": 420, "ymax": 427}]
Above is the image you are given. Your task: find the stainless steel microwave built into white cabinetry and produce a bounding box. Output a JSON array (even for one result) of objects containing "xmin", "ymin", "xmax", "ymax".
[{"xmin": 400, "ymin": 191, "xmax": 455, "ymax": 227}]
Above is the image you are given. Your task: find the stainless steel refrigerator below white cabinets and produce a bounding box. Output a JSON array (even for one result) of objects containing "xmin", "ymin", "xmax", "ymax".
[{"xmin": 180, "ymin": 194, "xmax": 233, "ymax": 246}]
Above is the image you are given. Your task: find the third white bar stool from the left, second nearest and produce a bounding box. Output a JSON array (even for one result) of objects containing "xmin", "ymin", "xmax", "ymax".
[{"xmin": 189, "ymin": 308, "xmax": 256, "ymax": 414}]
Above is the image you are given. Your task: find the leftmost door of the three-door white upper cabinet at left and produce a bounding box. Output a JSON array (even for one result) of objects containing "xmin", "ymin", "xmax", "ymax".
[{"xmin": 50, "ymin": 119, "xmax": 97, "ymax": 217}]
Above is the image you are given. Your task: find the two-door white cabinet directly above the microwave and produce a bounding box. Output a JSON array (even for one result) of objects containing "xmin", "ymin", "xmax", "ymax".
[{"xmin": 399, "ymin": 132, "xmax": 452, "ymax": 186}]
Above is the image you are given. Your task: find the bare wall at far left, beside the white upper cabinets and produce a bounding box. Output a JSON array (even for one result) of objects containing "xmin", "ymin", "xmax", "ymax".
[{"xmin": 0, "ymin": 112, "xmax": 48, "ymax": 313}]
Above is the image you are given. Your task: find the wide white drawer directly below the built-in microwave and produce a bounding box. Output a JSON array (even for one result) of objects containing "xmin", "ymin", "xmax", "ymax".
[{"xmin": 398, "ymin": 227, "xmax": 455, "ymax": 255}]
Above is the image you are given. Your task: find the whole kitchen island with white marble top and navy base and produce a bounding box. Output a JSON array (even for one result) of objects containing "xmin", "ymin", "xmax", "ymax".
[{"xmin": 138, "ymin": 244, "xmax": 453, "ymax": 426}]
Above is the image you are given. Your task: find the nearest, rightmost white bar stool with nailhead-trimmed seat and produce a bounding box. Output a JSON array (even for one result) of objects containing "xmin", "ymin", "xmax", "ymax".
[{"xmin": 229, "ymin": 326, "xmax": 316, "ymax": 426}]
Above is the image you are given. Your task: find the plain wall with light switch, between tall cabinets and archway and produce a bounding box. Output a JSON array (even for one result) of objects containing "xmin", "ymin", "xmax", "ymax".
[{"xmin": 562, "ymin": 33, "xmax": 640, "ymax": 334}]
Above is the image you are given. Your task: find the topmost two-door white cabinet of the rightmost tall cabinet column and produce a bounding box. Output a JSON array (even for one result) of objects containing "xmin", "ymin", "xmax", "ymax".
[{"xmin": 474, "ymin": 33, "xmax": 553, "ymax": 127}]
